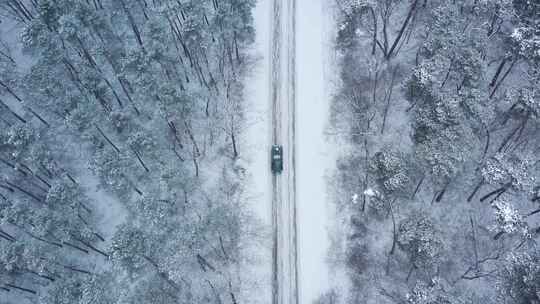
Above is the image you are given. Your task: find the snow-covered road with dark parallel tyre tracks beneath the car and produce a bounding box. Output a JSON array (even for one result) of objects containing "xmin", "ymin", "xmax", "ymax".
[{"xmin": 270, "ymin": 0, "xmax": 298, "ymax": 304}]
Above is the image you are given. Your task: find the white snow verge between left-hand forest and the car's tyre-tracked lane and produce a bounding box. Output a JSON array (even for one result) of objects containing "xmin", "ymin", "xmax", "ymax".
[{"xmin": 240, "ymin": 0, "xmax": 272, "ymax": 303}]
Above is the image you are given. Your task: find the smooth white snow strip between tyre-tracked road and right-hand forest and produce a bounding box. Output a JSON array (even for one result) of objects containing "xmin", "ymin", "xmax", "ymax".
[{"xmin": 296, "ymin": 0, "xmax": 335, "ymax": 304}]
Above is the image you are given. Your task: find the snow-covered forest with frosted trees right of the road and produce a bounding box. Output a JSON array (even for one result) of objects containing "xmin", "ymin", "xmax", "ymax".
[{"xmin": 330, "ymin": 0, "xmax": 540, "ymax": 304}]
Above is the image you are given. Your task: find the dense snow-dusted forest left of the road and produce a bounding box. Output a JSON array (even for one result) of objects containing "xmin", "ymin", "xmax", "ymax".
[{"xmin": 0, "ymin": 0, "xmax": 260, "ymax": 304}]
